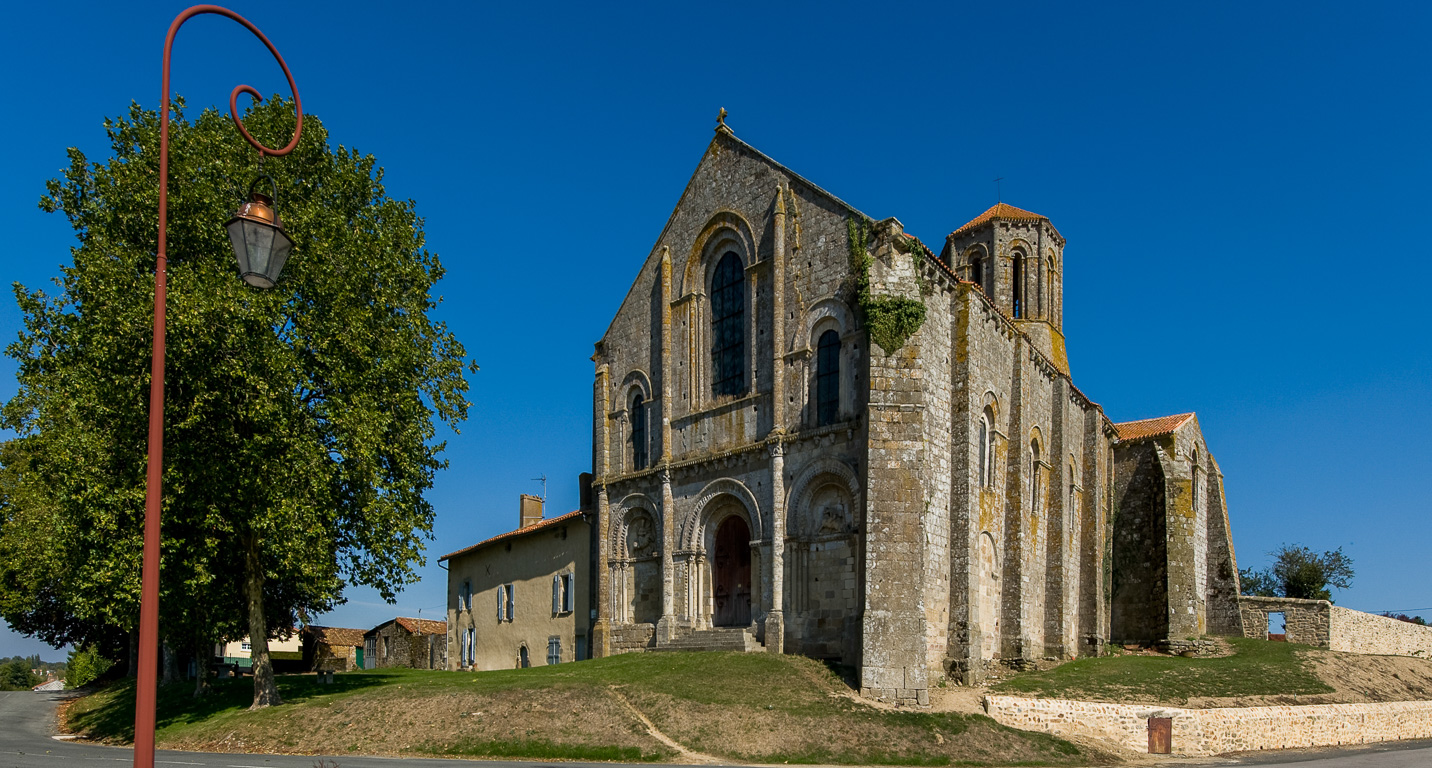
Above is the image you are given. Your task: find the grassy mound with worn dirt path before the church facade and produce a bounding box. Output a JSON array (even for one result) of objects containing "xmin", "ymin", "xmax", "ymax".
[{"xmin": 66, "ymin": 653, "xmax": 1090, "ymax": 765}]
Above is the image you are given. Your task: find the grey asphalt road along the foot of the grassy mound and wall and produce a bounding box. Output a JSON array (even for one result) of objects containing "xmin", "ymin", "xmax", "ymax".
[{"xmin": 0, "ymin": 691, "xmax": 1432, "ymax": 768}]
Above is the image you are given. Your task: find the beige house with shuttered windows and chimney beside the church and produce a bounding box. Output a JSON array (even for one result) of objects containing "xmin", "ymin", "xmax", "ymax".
[{"xmin": 440, "ymin": 494, "xmax": 591, "ymax": 671}]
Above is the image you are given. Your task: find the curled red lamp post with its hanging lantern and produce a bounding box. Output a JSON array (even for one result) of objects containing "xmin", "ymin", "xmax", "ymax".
[{"xmin": 135, "ymin": 6, "xmax": 304, "ymax": 768}]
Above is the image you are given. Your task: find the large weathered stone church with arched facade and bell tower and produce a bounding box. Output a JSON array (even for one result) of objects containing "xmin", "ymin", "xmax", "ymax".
[{"xmin": 590, "ymin": 122, "xmax": 1242, "ymax": 704}]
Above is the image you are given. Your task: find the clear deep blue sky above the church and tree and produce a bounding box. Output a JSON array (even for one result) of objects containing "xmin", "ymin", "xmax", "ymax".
[{"xmin": 0, "ymin": 1, "xmax": 1432, "ymax": 658}]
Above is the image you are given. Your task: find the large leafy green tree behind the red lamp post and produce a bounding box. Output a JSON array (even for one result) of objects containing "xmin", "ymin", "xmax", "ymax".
[{"xmin": 0, "ymin": 99, "xmax": 475, "ymax": 708}]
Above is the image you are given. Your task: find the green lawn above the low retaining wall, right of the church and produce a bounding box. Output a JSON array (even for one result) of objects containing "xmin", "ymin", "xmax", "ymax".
[{"xmin": 991, "ymin": 638, "xmax": 1333, "ymax": 704}]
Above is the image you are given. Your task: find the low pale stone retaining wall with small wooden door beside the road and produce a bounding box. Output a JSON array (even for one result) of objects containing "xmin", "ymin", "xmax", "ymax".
[{"xmin": 984, "ymin": 696, "xmax": 1432, "ymax": 755}]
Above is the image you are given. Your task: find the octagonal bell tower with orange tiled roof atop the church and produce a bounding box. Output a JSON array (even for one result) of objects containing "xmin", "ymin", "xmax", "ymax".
[{"xmin": 941, "ymin": 202, "xmax": 1070, "ymax": 374}]
